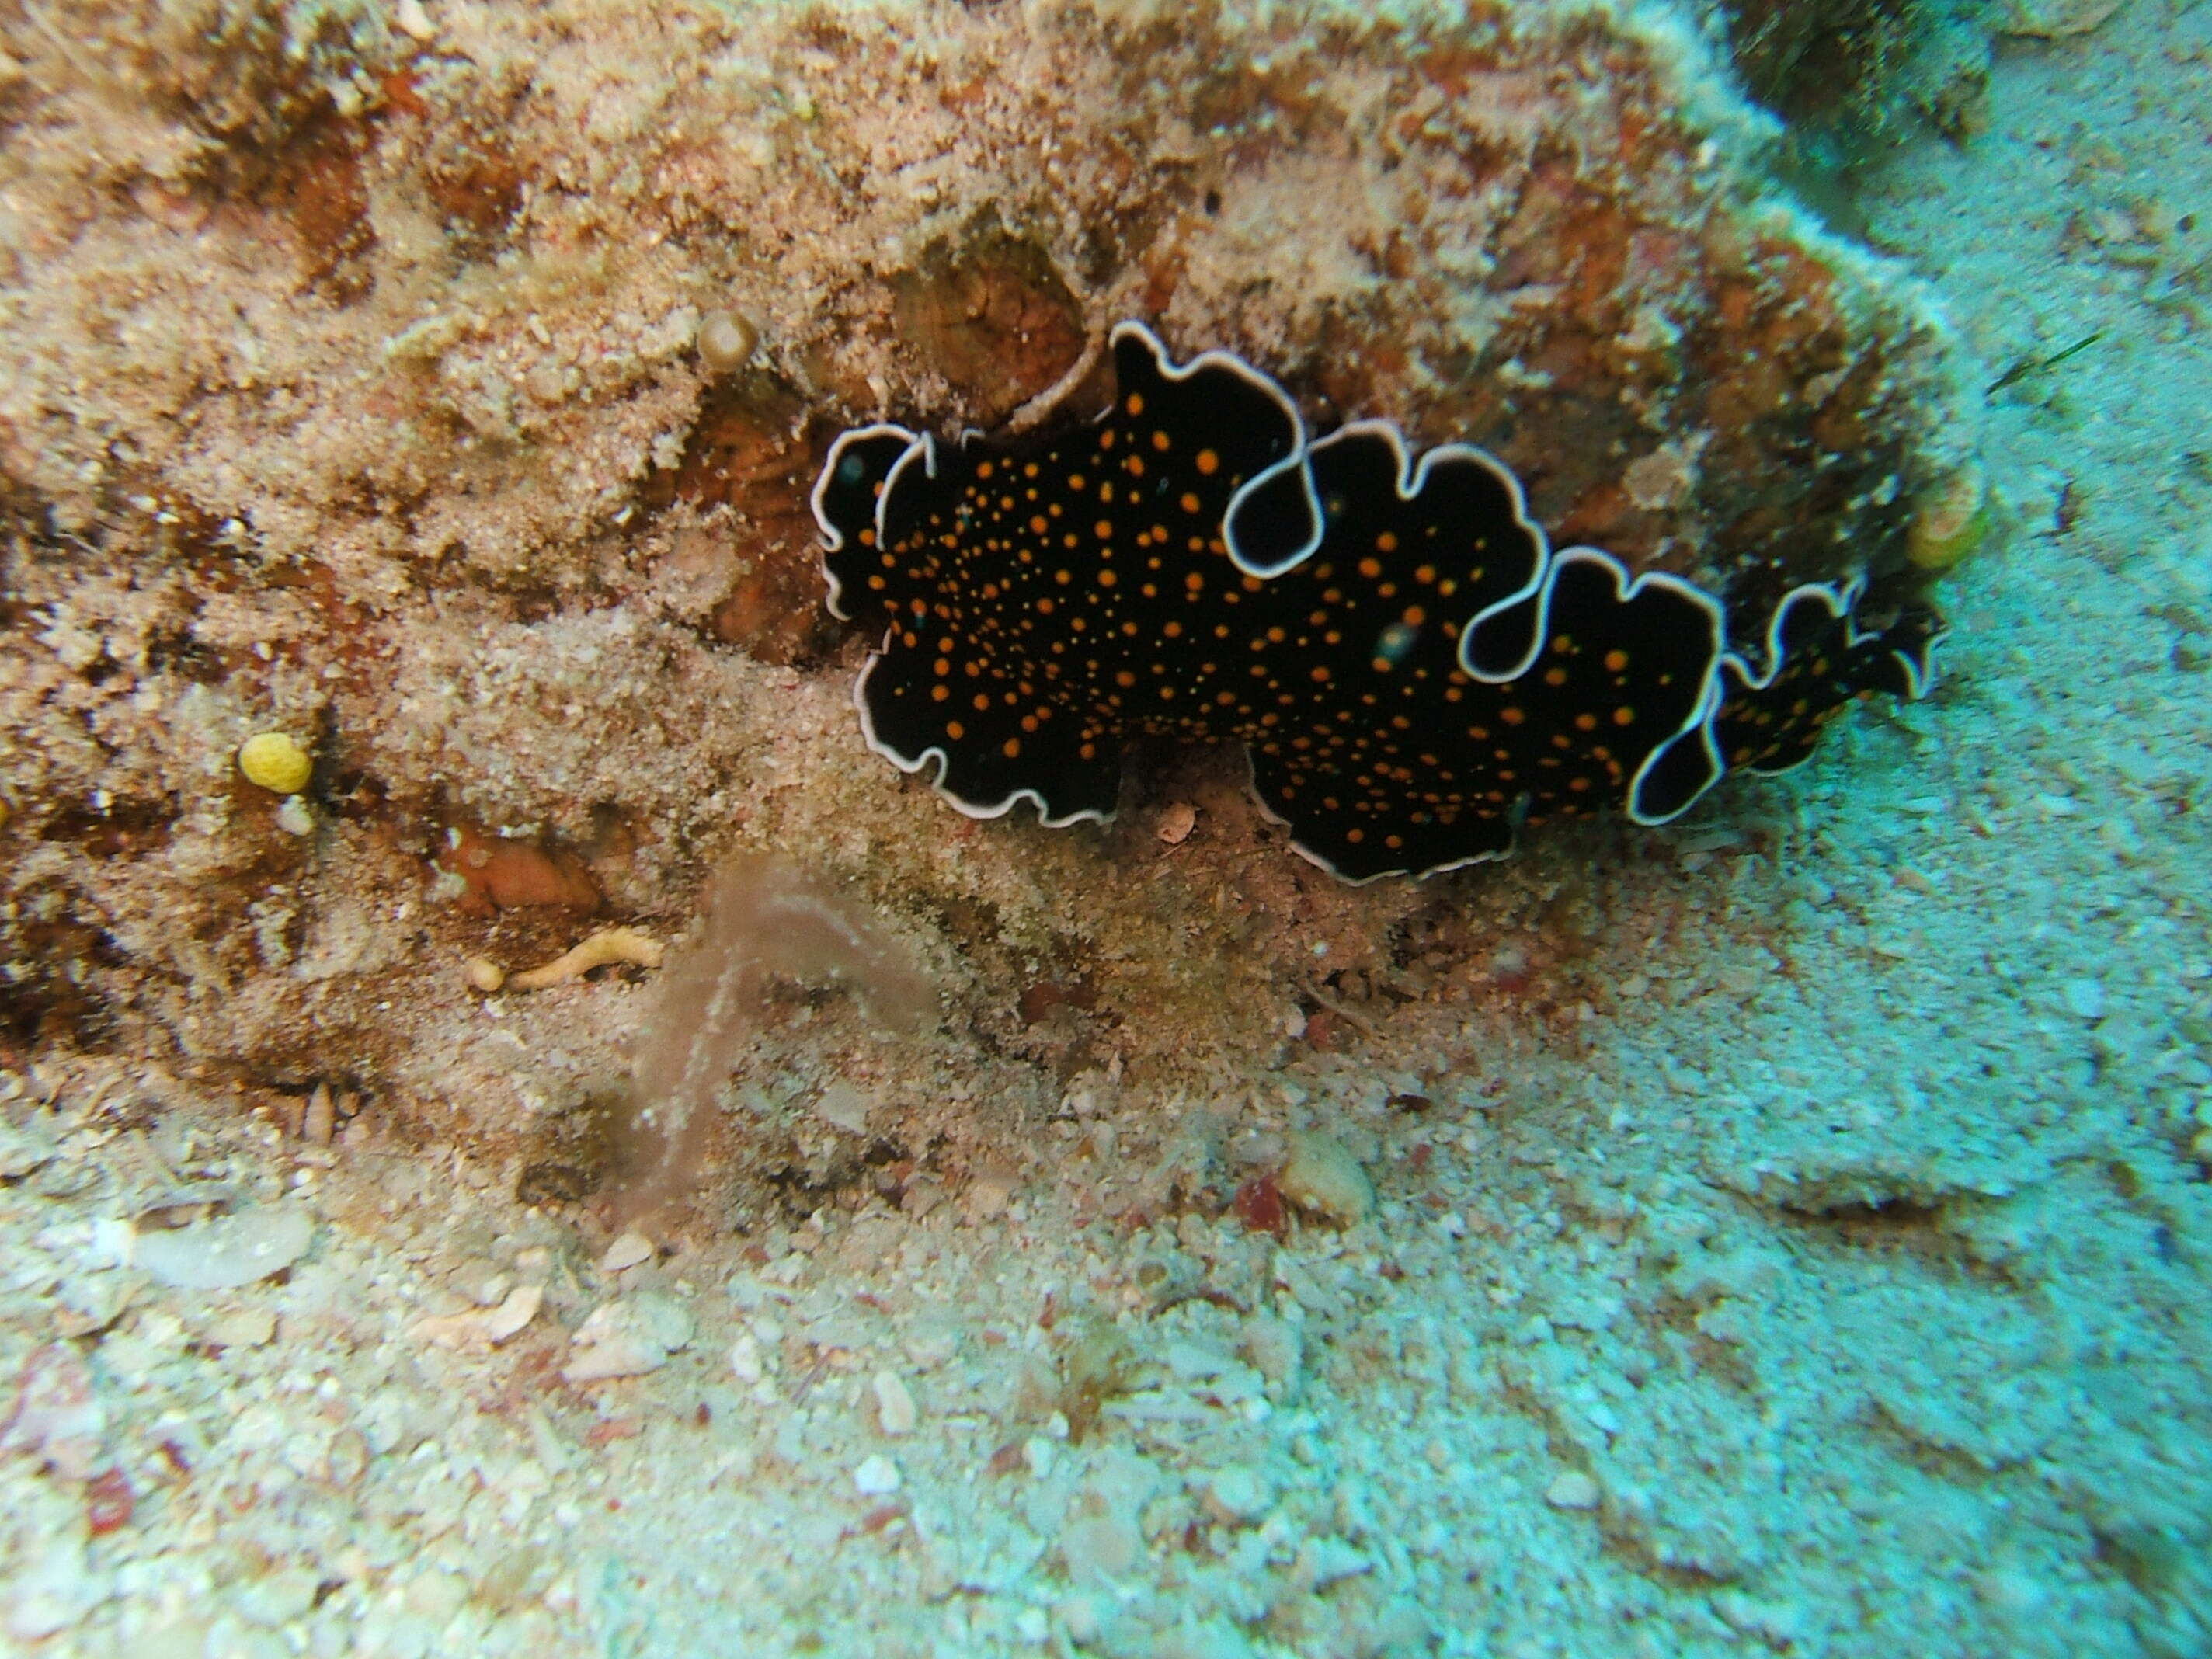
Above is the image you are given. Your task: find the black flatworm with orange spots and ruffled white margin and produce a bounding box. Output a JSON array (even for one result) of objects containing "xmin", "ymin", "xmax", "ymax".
[{"xmin": 814, "ymin": 323, "xmax": 1942, "ymax": 882}]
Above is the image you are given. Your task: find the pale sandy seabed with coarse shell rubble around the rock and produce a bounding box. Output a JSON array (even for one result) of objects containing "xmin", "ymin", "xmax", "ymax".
[{"xmin": 0, "ymin": 0, "xmax": 2212, "ymax": 1659}]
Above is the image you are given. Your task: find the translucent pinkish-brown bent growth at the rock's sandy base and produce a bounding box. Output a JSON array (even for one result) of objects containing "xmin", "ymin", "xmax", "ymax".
[{"xmin": 615, "ymin": 854, "xmax": 938, "ymax": 1216}]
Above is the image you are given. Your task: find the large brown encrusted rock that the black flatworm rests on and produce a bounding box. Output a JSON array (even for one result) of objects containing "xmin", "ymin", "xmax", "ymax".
[{"xmin": 0, "ymin": 0, "xmax": 1971, "ymax": 1122}]
